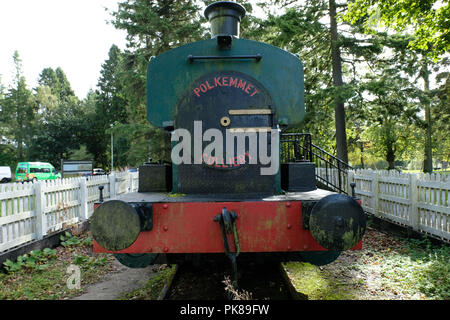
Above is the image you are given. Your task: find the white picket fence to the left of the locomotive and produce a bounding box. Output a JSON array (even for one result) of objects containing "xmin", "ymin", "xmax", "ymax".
[{"xmin": 0, "ymin": 172, "xmax": 138, "ymax": 252}]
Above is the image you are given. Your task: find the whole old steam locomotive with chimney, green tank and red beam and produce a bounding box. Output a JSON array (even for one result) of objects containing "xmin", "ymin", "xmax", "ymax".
[{"xmin": 90, "ymin": 1, "xmax": 365, "ymax": 267}]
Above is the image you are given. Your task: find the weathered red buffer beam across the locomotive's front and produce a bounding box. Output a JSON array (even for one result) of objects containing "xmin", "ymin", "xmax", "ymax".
[{"xmin": 94, "ymin": 201, "xmax": 361, "ymax": 253}]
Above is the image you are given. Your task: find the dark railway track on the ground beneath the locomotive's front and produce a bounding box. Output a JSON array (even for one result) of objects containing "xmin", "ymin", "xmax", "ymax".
[{"xmin": 160, "ymin": 261, "xmax": 301, "ymax": 300}]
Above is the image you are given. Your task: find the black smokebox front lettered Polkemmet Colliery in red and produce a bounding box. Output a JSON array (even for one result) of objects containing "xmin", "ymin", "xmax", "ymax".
[{"xmin": 174, "ymin": 71, "xmax": 279, "ymax": 194}]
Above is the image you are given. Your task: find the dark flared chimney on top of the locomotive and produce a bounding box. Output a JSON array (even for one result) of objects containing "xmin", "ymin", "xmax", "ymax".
[{"xmin": 205, "ymin": 1, "xmax": 245, "ymax": 38}]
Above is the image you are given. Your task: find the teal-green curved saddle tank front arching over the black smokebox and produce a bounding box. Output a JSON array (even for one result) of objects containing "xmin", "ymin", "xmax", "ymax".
[{"xmin": 147, "ymin": 37, "xmax": 305, "ymax": 127}]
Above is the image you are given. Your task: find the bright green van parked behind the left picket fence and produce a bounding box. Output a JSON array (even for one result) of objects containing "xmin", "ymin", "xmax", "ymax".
[{"xmin": 16, "ymin": 162, "xmax": 61, "ymax": 181}]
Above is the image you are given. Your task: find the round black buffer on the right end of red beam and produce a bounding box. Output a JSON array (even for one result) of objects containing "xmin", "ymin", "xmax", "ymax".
[{"xmin": 309, "ymin": 194, "xmax": 366, "ymax": 251}]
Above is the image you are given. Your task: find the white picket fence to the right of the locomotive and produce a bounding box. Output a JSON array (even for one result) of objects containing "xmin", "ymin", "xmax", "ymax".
[{"xmin": 346, "ymin": 170, "xmax": 450, "ymax": 241}]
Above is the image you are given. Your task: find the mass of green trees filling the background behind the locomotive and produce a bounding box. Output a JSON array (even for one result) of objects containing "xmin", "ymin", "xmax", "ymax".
[{"xmin": 0, "ymin": 0, "xmax": 450, "ymax": 169}]
